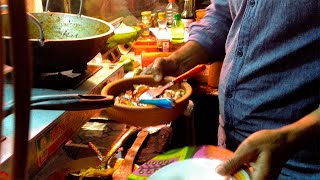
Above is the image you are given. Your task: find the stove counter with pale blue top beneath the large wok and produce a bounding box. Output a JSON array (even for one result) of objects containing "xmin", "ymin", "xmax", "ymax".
[{"xmin": 0, "ymin": 51, "xmax": 124, "ymax": 176}]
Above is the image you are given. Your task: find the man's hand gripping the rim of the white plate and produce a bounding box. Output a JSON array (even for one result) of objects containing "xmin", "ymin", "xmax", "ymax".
[{"xmin": 216, "ymin": 130, "xmax": 292, "ymax": 180}]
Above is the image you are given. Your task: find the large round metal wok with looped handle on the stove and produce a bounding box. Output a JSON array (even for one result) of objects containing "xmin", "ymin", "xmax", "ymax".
[{"xmin": 1, "ymin": 12, "xmax": 114, "ymax": 73}]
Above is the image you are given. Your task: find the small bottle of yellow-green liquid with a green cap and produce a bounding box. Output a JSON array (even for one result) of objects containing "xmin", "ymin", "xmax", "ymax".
[{"xmin": 171, "ymin": 13, "xmax": 184, "ymax": 44}]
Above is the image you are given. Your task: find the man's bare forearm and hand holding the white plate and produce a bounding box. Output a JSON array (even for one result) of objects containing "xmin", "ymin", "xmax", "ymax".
[{"xmin": 216, "ymin": 108, "xmax": 320, "ymax": 180}]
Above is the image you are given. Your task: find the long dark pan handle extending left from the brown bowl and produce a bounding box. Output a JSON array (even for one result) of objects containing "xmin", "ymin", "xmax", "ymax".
[{"xmin": 3, "ymin": 94, "xmax": 114, "ymax": 116}]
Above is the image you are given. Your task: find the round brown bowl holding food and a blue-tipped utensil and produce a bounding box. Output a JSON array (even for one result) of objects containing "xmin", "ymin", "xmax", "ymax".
[{"xmin": 101, "ymin": 75, "xmax": 192, "ymax": 127}]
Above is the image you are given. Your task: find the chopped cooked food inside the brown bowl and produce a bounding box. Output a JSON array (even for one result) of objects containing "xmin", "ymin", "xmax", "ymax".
[{"xmin": 115, "ymin": 84, "xmax": 186, "ymax": 106}]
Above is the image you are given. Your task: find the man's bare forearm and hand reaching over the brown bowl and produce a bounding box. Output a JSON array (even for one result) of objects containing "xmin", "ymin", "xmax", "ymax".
[{"xmin": 142, "ymin": 41, "xmax": 208, "ymax": 81}]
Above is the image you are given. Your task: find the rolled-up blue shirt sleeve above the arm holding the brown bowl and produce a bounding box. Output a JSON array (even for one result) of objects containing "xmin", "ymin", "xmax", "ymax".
[{"xmin": 188, "ymin": 0, "xmax": 232, "ymax": 58}]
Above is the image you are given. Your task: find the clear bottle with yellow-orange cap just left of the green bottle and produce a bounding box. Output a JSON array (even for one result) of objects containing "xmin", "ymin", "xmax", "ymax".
[{"xmin": 157, "ymin": 12, "xmax": 171, "ymax": 52}]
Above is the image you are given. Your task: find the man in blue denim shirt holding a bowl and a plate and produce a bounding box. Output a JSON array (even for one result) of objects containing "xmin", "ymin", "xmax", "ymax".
[{"xmin": 143, "ymin": 0, "xmax": 320, "ymax": 179}]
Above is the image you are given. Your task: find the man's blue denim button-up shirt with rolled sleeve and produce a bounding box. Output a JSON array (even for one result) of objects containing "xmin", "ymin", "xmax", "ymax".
[{"xmin": 189, "ymin": 0, "xmax": 320, "ymax": 179}]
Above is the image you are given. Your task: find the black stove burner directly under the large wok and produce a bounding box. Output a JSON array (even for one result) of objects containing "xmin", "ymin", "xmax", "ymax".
[{"xmin": 33, "ymin": 64, "xmax": 102, "ymax": 90}]
